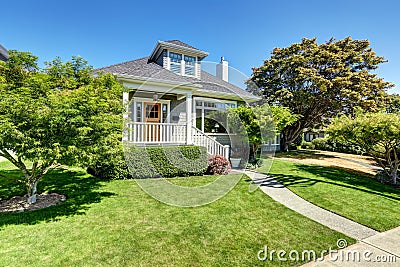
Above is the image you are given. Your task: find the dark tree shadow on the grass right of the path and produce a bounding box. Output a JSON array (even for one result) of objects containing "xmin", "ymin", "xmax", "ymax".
[{"xmin": 270, "ymin": 164, "xmax": 400, "ymax": 200}]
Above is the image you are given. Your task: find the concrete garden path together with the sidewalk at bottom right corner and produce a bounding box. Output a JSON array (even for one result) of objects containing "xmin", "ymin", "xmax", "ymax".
[{"xmin": 245, "ymin": 171, "xmax": 400, "ymax": 267}]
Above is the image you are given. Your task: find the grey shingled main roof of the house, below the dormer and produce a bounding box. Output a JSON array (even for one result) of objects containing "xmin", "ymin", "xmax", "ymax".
[{"xmin": 96, "ymin": 57, "xmax": 259, "ymax": 101}]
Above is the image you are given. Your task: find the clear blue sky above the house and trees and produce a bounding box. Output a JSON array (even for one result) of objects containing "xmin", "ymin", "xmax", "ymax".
[{"xmin": 0, "ymin": 0, "xmax": 400, "ymax": 93}]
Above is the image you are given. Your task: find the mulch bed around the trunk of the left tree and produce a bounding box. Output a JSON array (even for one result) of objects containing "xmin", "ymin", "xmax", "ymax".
[{"xmin": 0, "ymin": 193, "xmax": 67, "ymax": 215}]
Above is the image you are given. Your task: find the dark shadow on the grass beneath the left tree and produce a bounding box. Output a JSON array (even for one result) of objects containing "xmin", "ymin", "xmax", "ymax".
[{"xmin": 0, "ymin": 169, "xmax": 114, "ymax": 229}]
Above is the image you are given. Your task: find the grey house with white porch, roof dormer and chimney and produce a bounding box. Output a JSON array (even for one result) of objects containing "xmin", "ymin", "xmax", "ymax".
[{"xmin": 98, "ymin": 40, "xmax": 259, "ymax": 158}]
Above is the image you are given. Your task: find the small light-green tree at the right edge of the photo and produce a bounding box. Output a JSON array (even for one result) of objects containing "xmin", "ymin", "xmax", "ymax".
[{"xmin": 327, "ymin": 112, "xmax": 400, "ymax": 184}]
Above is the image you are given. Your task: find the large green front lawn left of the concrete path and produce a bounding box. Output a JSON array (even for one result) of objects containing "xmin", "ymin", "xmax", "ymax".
[{"xmin": 0, "ymin": 163, "xmax": 354, "ymax": 266}]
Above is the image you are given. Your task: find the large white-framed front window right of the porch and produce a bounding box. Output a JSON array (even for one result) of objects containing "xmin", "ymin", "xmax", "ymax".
[{"xmin": 196, "ymin": 99, "xmax": 236, "ymax": 133}]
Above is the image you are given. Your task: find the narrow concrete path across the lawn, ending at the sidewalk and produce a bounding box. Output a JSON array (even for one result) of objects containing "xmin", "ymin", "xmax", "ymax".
[{"xmin": 245, "ymin": 171, "xmax": 378, "ymax": 240}]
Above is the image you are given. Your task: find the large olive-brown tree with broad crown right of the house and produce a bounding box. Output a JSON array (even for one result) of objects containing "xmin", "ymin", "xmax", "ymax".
[{"xmin": 249, "ymin": 37, "xmax": 393, "ymax": 151}]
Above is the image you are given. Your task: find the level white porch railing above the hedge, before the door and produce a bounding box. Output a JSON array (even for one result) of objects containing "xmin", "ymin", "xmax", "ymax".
[{"xmin": 128, "ymin": 122, "xmax": 186, "ymax": 144}]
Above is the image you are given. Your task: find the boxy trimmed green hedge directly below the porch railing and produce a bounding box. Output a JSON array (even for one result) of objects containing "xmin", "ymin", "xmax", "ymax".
[{"xmin": 125, "ymin": 146, "xmax": 208, "ymax": 178}]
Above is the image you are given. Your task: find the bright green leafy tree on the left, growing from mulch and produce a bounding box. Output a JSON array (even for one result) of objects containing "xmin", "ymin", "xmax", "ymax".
[{"xmin": 0, "ymin": 51, "xmax": 122, "ymax": 203}]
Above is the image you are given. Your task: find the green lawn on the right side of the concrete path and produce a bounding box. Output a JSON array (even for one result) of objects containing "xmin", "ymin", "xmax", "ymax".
[{"xmin": 260, "ymin": 159, "xmax": 400, "ymax": 231}]
